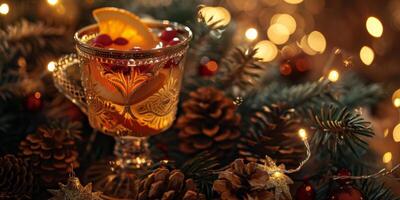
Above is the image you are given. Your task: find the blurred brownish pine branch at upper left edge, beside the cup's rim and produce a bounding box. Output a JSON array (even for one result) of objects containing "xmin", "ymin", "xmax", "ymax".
[{"xmin": 0, "ymin": 20, "xmax": 66, "ymax": 61}]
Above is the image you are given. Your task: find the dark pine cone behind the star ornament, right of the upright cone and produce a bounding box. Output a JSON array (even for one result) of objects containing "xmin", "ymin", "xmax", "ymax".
[{"xmin": 238, "ymin": 104, "xmax": 305, "ymax": 168}]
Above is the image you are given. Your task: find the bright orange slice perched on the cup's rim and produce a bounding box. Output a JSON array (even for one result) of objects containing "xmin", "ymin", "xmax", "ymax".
[{"xmin": 93, "ymin": 7, "xmax": 158, "ymax": 50}]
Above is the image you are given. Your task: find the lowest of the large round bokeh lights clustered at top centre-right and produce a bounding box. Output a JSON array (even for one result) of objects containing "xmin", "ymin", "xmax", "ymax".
[{"xmin": 254, "ymin": 40, "xmax": 278, "ymax": 62}]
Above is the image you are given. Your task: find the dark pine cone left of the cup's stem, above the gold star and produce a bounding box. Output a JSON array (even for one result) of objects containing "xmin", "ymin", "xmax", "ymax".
[{"xmin": 19, "ymin": 125, "xmax": 79, "ymax": 187}]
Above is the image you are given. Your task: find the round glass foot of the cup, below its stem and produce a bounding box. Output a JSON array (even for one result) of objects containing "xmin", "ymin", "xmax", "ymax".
[{"xmin": 85, "ymin": 160, "xmax": 146, "ymax": 200}]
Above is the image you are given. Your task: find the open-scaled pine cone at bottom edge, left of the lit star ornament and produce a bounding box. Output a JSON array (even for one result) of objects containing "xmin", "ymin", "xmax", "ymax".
[{"xmin": 213, "ymin": 159, "xmax": 273, "ymax": 200}]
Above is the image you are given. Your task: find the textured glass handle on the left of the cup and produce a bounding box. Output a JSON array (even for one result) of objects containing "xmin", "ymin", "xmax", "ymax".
[{"xmin": 53, "ymin": 54, "xmax": 87, "ymax": 114}]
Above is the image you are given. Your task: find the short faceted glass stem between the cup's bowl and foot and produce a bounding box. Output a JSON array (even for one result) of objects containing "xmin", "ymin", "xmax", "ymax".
[{"xmin": 114, "ymin": 136, "xmax": 152, "ymax": 171}]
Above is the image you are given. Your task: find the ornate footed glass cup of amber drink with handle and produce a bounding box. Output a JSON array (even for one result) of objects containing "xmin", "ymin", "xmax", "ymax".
[{"xmin": 53, "ymin": 21, "xmax": 192, "ymax": 199}]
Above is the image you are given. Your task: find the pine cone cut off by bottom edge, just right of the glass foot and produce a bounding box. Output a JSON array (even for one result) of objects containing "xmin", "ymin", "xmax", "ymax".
[{"xmin": 138, "ymin": 168, "xmax": 205, "ymax": 200}]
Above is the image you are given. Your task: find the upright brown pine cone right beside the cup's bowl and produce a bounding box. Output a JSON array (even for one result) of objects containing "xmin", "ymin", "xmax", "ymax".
[{"xmin": 176, "ymin": 87, "xmax": 240, "ymax": 154}]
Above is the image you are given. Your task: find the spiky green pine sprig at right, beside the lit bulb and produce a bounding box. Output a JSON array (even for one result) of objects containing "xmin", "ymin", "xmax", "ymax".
[{"xmin": 309, "ymin": 105, "xmax": 374, "ymax": 157}]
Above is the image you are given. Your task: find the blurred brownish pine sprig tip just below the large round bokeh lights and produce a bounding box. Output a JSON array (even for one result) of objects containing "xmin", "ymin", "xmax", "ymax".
[{"xmin": 220, "ymin": 47, "xmax": 264, "ymax": 91}]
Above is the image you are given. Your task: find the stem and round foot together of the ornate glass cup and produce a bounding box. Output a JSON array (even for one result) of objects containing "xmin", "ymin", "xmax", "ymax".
[{"xmin": 85, "ymin": 137, "xmax": 152, "ymax": 200}]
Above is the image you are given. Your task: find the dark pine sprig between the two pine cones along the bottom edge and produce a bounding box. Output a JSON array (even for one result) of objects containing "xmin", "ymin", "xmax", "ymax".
[{"xmin": 181, "ymin": 152, "xmax": 219, "ymax": 199}]
